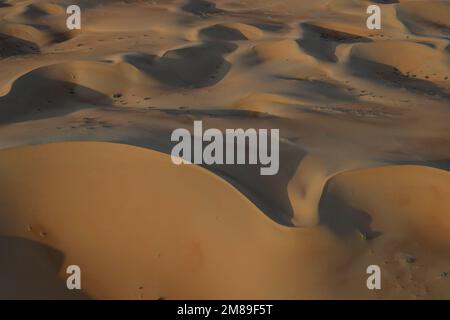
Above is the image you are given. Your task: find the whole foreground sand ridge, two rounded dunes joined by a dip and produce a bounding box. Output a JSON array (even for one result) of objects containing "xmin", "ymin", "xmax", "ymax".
[{"xmin": 0, "ymin": 142, "xmax": 450, "ymax": 299}]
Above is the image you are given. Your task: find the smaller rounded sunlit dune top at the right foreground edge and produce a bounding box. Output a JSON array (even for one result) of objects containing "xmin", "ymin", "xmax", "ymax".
[{"xmin": 325, "ymin": 165, "xmax": 450, "ymax": 248}]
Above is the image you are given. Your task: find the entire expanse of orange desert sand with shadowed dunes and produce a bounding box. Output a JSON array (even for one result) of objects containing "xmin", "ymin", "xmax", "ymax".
[{"xmin": 0, "ymin": 0, "xmax": 450, "ymax": 299}]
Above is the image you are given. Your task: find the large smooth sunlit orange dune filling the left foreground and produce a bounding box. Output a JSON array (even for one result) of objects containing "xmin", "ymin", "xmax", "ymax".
[{"xmin": 0, "ymin": 143, "xmax": 342, "ymax": 299}]
